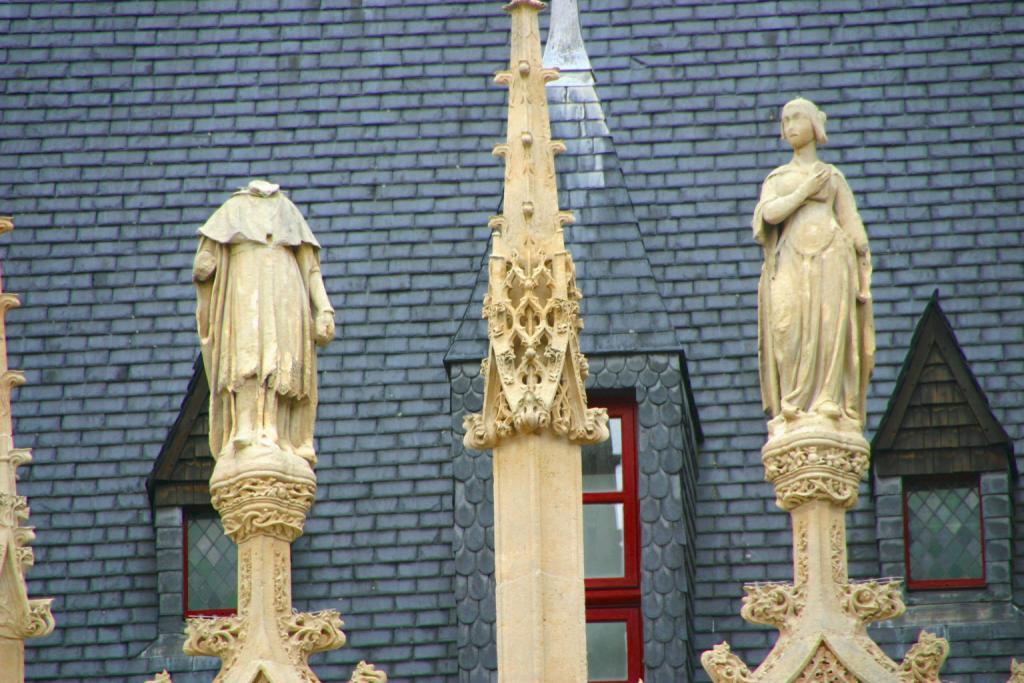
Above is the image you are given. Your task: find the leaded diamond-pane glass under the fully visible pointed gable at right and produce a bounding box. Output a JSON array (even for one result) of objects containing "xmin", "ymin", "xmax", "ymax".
[{"xmin": 906, "ymin": 482, "xmax": 985, "ymax": 581}]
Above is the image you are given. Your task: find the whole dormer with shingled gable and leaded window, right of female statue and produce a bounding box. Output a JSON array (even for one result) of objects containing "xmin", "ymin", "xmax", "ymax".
[{"xmin": 872, "ymin": 293, "xmax": 1015, "ymax": 608}]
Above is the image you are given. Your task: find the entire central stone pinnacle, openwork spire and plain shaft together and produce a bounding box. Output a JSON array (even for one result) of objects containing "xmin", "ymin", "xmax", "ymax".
[{"xmin": 465, "ymin": 0, "xmax": 608, "ymax": 683}]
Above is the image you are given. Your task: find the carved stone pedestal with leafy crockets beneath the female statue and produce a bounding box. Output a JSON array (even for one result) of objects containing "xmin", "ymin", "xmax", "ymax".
[{"xmin": 700, "ymin": 418, "xmax": 949, "ymax": 683}]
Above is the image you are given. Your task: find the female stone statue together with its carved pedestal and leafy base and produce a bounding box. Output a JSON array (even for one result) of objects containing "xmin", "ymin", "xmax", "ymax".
[{"xmin": 701, "ymin": 99, "xmax": 948, "ymax": 683}]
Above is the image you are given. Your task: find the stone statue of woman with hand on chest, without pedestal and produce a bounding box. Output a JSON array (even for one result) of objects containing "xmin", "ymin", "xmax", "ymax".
[{"xmin": 754, "ymin": 98, "xmax": 874, "ymax": 429}]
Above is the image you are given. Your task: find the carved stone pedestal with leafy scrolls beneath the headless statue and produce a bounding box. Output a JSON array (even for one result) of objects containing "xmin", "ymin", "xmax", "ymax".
[{"xmin": 184, "ymin": 445, "xmax": 345, "ymax": 683}]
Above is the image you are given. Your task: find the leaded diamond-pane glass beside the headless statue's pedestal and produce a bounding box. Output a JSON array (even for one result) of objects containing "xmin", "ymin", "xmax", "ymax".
[{"xmin": 186, "ymin": 510, "xmax": 238, "ymax": 611}]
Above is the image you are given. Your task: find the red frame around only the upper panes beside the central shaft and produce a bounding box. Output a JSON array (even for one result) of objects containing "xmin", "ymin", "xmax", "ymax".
[{"xmin": 583, "ymin": 399, "xmax": 640, "ymax": 592}]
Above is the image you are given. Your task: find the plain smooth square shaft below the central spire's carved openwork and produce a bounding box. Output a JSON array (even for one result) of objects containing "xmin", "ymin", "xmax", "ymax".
[{"xmin": 494, "ymin": 432, "xmax": 587, "ymax": 683}]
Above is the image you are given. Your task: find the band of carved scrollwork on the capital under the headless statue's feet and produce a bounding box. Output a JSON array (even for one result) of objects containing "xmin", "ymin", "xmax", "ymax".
[{"xmin": 210, "ymin": 475, "xmax": 316, "ymax": 543}]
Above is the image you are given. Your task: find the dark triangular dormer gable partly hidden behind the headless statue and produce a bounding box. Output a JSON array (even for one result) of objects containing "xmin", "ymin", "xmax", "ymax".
[{"xmin": 145, "ymin": 355, "xmax": 213, "ymax": 506}]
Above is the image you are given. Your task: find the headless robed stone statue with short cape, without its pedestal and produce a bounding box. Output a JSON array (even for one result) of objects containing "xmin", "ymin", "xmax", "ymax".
[{"xmin": 193, "ymin": 180, "xmax": 334, "ymax": 465}]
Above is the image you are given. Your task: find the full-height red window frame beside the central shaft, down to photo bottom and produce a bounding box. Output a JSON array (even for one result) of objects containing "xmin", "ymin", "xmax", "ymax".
[{"xmin": 583, "ymin": 398, "xmax": 643, "ymax": 683}]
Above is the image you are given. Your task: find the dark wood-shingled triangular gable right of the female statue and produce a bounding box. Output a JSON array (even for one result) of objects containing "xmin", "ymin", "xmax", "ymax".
[{"xmin": 871, "ymin": 290, "xmax": 1015, "ymax": 476}]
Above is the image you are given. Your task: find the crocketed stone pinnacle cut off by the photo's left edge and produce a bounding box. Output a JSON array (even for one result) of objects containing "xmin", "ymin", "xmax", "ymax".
[{"xmin": 0, "ymin": 216, "xmax": 53, "ymax": 683}]
